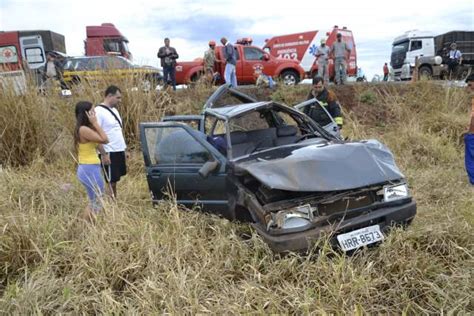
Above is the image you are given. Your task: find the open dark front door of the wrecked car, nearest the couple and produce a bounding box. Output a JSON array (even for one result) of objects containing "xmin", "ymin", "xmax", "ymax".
[{"xmin": 140, "ymin": 122, "xmax": 228, "ymax": 214}]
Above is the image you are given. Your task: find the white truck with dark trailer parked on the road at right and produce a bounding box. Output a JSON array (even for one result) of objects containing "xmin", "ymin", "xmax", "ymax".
[{"xmin": 390, "ymin": 30, "xmax": 474, "ymax": 80}]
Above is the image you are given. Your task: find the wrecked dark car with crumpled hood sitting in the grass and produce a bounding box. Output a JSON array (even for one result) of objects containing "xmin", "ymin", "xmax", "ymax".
[{"xmin": 140, "ymin": 86, "xmax": 416, "ymax": 252}]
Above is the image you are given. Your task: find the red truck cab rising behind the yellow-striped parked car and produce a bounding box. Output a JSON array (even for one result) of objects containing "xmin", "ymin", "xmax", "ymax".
[{"xmin": 84, "ymin": 23, "xmax": 132, "ymax": 60}]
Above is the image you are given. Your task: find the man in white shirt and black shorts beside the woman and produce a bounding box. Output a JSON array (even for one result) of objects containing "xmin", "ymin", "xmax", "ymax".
[{"xmin": 95, "ymin": 86, "xmax": 127, "ymax": 198}]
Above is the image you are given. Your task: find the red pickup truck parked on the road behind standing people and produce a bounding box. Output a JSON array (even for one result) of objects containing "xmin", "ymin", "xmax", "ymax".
[{"xmin": 176, "ymin": 44, "xmax": 305, "ymax": 85}]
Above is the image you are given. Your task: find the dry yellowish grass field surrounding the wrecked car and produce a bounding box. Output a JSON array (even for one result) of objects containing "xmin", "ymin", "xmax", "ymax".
[{"xmin": 0, "ymin": 82, "xmax": 474, "ymax": 314}]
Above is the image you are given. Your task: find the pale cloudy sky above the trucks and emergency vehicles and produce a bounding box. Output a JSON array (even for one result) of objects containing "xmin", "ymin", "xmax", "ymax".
[{"xmin": 0, "ymin": 0, "xmax": 474, "ymax": 79}]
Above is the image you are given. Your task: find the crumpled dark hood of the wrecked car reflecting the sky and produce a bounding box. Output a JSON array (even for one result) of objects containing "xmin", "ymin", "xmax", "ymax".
[{"xmin": 235, "ymin": 140, "xmax": 404, "ymax": 192}]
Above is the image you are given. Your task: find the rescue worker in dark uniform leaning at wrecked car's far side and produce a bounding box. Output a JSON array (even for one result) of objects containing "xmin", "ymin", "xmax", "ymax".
[{"xmin": 303, "ymin": 76, "xmax": 343, "ymax": 129}]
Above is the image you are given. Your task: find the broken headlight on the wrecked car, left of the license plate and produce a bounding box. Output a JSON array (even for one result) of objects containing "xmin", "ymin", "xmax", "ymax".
[{"xmin": 267, "ymin": 204, "xmax": 314, "ymax": 230}]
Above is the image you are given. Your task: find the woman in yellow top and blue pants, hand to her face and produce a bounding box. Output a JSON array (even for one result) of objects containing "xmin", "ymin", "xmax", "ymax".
[{"xmin": 74, "ymin": 101, "xmax": 109, "ymax": 220}]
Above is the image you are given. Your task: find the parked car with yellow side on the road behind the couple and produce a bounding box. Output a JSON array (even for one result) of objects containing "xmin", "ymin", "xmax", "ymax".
[{"xmin": 63, "ymin": 56, "xmax": 163, "ymax": 90}]
